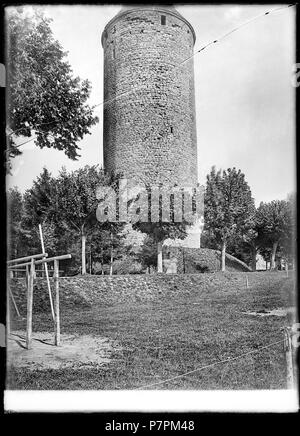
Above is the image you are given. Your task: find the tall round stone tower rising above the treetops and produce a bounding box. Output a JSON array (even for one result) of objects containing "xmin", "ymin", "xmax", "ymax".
[{"xmin": 101, "ymin": 5, "xmax": 197, "ymax": 186}]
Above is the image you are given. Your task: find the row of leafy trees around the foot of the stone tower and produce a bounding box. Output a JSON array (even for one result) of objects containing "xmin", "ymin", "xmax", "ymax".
[{"xmin": 7, "ymin": 162, "xmax": 296, "ymax": 274}]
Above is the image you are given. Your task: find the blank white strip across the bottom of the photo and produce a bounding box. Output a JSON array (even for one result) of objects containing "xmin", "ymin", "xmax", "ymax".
[{"xmin": 4, "ymin": 390, "xmax": 299, "ymax": 412}]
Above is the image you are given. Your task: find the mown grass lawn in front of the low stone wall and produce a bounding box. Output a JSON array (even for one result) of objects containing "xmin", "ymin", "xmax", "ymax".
[{"xmin": 7, "ymin": 272, "xmax": 294, "ymax": 390}]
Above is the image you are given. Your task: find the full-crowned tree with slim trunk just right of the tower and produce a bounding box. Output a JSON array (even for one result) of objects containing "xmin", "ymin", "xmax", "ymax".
[{"xmin": 204, "ymin": 167, "xmax": 255, "ymax": 271}]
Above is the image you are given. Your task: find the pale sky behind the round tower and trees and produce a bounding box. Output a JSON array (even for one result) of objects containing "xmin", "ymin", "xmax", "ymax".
[{"xmin": 7, "ymin": 4, "xmax": 296, "ymax": 205}]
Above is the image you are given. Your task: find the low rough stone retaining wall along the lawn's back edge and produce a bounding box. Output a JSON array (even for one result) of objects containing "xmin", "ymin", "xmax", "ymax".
[{"xmin": 10, "ymin": 273, "xmax": 254, "ymax": 314}]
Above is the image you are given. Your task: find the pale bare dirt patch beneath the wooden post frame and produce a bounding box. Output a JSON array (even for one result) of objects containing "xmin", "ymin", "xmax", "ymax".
[{"xmin": 7, "ymin": 331, "xmax": 116, "ymax": 369}]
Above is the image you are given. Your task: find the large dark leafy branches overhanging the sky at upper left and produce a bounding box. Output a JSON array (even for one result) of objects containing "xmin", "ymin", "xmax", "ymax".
[{"xmin": 7, "ymin": 7, "xmax": 98, "ymax": 169}]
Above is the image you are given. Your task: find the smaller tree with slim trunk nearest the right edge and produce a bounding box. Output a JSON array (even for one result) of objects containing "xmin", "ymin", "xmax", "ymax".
[{"xmin": 257, "ymin": 200, "xmax": 294, "ymax": 270}]
